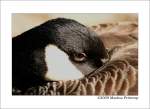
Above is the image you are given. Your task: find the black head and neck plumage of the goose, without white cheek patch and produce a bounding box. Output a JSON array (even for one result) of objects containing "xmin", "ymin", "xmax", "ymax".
[{"xmin": 12, "ymin": 18, "xmax": 108, "ymax": 90}]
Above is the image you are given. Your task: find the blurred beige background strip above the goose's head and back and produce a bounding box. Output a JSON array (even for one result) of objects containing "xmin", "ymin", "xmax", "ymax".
[{"xmin": 12, "ymin": 13, "xmax": 138, "ymax": 37}]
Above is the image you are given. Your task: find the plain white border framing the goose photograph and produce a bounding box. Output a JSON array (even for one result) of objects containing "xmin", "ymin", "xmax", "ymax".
[{"xmin": 1, "ymin": 1, "xmax": 149, "ymax": 108}]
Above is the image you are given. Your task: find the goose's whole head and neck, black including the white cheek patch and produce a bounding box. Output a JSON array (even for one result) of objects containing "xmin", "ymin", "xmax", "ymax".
[{"xmin": 12, "ymin": 18, "xmax": 108, "ymax": 90}]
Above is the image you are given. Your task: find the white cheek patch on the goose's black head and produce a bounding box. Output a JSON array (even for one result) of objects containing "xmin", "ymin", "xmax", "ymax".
[{"xmin": 45, "ymin": 45, "xmax": 84, "ymax": 80}]
